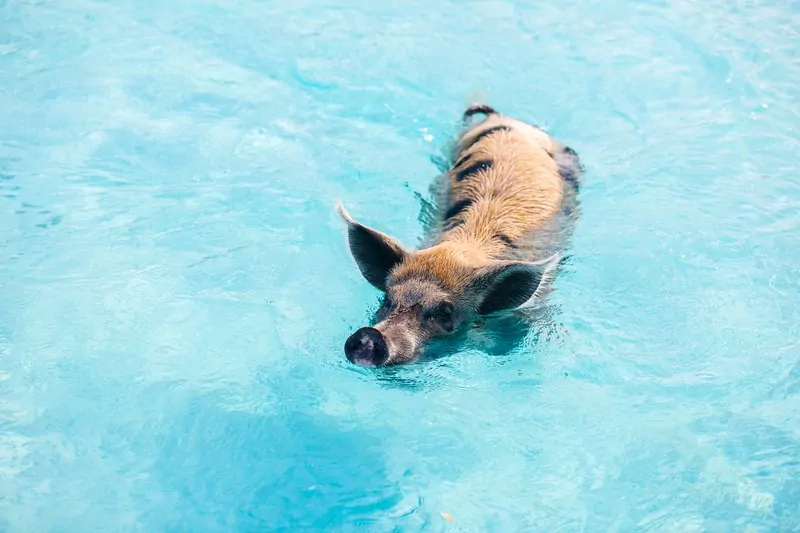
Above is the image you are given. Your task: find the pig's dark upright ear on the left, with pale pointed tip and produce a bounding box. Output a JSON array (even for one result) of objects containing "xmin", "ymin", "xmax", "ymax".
[{"xmin": 336, "ymin": 202, "xmax": 407, "ymax": 291}]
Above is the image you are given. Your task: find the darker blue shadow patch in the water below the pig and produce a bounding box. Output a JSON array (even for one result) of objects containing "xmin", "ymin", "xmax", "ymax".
[{"xmin": 147, "ymin": 390, "xmax": 412, "ymax": 531}]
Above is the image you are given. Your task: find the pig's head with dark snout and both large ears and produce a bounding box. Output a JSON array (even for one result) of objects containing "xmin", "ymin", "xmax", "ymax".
[{"xmin": 338, "ymin": 204, "xmax": 557, "ymax": 367}]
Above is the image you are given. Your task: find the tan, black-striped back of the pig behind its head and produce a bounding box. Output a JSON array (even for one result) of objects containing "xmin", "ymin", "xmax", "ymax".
[{"xmin": 437, "ymin": 114, "xmax": 581, "ymax": 257}]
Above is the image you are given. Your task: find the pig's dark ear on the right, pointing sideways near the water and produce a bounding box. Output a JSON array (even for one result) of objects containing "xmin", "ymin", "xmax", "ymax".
[{"xmin": 472, "ymin": 254, "xmax": 561, "ymax": 315}]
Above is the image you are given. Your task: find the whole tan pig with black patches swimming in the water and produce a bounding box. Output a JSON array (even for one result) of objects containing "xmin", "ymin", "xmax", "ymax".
[{"xmin": 338, "ymin": 105, "xmax": 583, "ymax": 367}]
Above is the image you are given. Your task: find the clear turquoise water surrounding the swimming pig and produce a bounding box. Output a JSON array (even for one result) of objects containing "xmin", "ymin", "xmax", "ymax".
[{"xmin": 0, "ymin": 0, "xmax": 800, "ymax": 533}]
